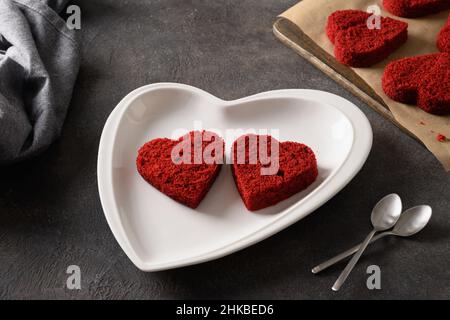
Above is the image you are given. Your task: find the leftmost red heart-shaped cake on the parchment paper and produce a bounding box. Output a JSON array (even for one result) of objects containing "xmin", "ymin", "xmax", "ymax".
[{"xmin": 326, "ymin": 10, "xmax": 408, "ymax": 68}]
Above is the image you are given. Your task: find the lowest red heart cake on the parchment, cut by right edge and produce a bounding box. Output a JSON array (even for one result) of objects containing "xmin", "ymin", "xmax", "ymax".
[{"xmin": 382, "ymin": 53, "xmax": 450, "ymax": 115}]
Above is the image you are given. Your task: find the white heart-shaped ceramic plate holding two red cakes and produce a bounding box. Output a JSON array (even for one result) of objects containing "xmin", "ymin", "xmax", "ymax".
[{"xmin": 98, "ymin": 83, "xmax": 372, "ymax": 271}]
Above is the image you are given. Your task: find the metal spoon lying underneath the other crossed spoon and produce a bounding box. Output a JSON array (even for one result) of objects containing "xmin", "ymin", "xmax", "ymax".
[{"xmin": 312, "ymin": 206, "xmax": 433, "ymax": 274}]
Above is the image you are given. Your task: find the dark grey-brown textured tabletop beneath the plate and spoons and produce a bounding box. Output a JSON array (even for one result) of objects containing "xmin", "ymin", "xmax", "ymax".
[{"xmin": 0, "ymin": 0, "xmax": 450, "ymax": 299}]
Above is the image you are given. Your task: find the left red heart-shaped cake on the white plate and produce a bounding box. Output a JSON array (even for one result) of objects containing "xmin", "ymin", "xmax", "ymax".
[{"xmin": 136, "ymin": 131, "xmax": 224, "ymax": 208}]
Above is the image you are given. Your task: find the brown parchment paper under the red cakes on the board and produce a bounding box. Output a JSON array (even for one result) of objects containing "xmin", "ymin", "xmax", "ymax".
[{"xmin": 280, "ymin": 0, "xmax": 450, "ymax": 171}]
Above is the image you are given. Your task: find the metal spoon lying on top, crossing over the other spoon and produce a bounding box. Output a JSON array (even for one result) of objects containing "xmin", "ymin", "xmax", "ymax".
[{"xmin": 332, "ymin": 193, "xmax": 402, "ymax": 291}]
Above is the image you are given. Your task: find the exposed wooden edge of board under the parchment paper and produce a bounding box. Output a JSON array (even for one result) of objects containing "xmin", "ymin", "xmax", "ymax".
[{"xmin": 273, "ymin": 18, "xmax": 422, "ymax": 143}]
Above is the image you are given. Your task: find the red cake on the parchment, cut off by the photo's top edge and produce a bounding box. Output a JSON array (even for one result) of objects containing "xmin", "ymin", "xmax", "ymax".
[{"xmin": 383, "ymin": 0, "xmax": 450, "ymax": 18}]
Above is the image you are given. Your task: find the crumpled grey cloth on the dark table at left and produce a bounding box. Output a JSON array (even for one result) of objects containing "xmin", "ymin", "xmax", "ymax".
[{"xmin": 0, "ymin": 0, "xmax": 81, "ymax": 165}]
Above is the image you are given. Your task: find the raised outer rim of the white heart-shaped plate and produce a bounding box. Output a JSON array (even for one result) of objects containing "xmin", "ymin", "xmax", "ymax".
[{"xmin": 97, "ymin": 82, "xmax": 373, "ymax": 272}]
